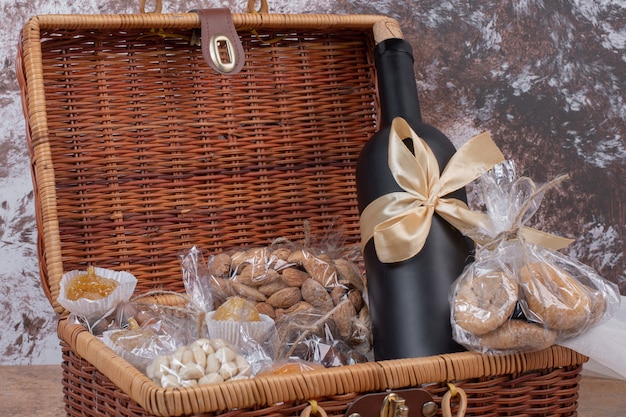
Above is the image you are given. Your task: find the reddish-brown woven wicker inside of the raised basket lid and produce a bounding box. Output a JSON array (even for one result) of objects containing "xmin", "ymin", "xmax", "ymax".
[{"xmin": 19, "ymin": 12, "xmax": 394, "ymax": 309}]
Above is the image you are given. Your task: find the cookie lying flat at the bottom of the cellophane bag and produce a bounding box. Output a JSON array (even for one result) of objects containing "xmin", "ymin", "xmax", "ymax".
[{"xmin": 478, "ymin": 320, "xmax": 557, "ymax": 352}]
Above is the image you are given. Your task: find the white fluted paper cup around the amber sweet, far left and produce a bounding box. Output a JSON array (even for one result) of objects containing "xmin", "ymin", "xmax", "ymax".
[{"xmin": 57, "ymin": 268, "xmax": 137, "ymax": 318}]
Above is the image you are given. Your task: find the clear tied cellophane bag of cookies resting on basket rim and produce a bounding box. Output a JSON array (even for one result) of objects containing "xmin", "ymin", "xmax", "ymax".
[{"xmin": 450, "ymin": 161, "xmax": 620, "ymax": 354}]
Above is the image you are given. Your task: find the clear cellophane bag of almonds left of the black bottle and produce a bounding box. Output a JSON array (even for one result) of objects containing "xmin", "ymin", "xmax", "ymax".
[{"xmin": 180, "ymin": 224, "xmax": 371, "ymax": 366}]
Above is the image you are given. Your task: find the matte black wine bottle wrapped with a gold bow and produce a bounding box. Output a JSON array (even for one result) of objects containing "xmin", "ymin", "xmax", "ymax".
[{"xmin": 356, "ymin": 38, "xmax": 472, "ymax": 360}]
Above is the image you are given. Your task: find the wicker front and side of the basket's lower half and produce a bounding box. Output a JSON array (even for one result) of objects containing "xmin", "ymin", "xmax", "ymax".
[{"xmin": 59, "ymin": 321, "xmax": 584, "ymax": 417}]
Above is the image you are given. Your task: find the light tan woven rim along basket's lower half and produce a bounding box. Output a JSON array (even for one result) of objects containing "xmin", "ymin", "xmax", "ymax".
[{"xmin": 57, "ymin": 319, "xmax": 588, "ymax": 416}]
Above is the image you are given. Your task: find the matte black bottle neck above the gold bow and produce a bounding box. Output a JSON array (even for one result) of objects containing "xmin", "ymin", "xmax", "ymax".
[{"xmin": 374, "ymin": 38, "xmax": 422, "ymax": 126}]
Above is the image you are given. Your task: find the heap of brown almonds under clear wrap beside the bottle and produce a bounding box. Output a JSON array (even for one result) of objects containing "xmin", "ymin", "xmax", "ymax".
[{"xmin": 209, "ymin": 247, "xmax": 369, "ymax": 343}]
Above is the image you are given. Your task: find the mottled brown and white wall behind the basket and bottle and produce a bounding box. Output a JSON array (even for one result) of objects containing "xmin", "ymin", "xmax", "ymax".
[{"xmin": 0, "ymin": 0, "xmax": 626, "ymax": 365}]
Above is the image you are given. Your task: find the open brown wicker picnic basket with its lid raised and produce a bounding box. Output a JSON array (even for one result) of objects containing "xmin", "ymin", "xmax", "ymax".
[{"xmin": 18, "ymin": 6, "xmax": 586, "ymax": 416}]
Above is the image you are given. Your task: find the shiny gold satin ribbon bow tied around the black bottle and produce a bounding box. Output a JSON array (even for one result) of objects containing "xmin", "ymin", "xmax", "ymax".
[{"xmin": 360, "ymin": 118, "xmax": 571, "ymax": 263}]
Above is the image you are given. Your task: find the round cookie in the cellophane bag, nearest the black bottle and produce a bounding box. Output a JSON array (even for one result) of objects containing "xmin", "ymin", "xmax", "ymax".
[{"xmin": 453, "ymin": 271, "xmax": 518, "ymax": 336}]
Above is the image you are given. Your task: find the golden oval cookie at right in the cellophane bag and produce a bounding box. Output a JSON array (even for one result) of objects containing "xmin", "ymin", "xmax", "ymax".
[{"xmin": 519, "ymin": 262, "xmax": 592, "ymax": 330}]
